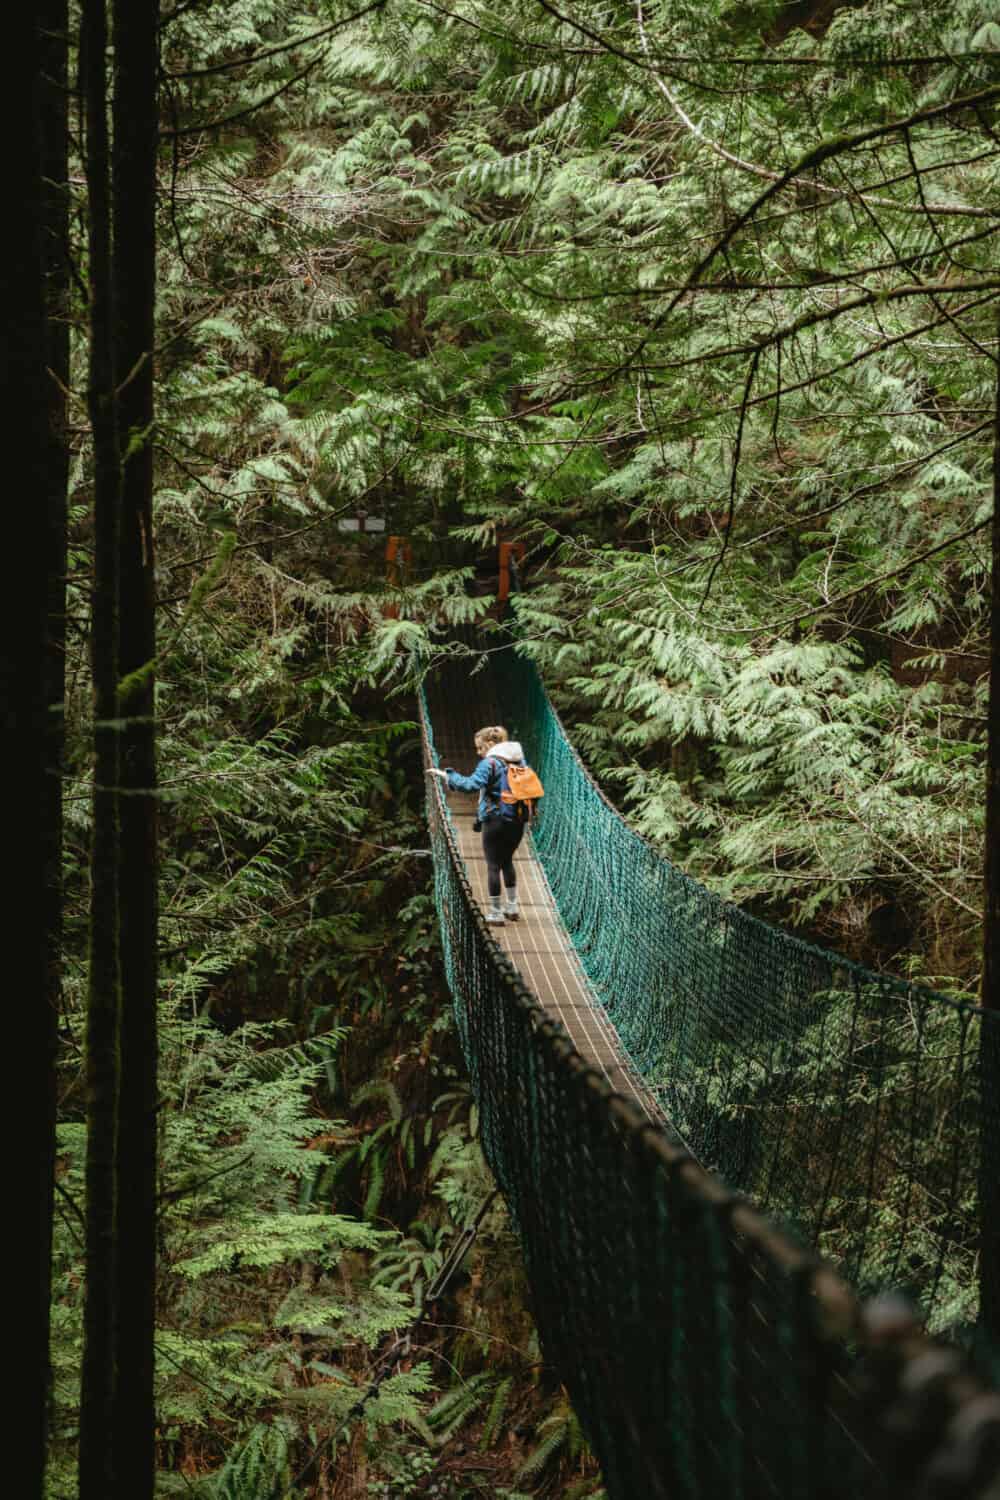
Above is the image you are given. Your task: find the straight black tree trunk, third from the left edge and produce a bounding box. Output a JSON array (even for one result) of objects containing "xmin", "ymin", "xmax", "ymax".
[{"xmin": 112, "ymin": 0, "xmax": 159, "ymax": 1500}]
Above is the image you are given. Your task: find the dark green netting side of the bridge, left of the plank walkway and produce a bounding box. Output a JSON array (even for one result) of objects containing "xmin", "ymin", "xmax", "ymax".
[{"xmin": 424, "ymin": 690, "xmax": 1000, "ymax": 1500}]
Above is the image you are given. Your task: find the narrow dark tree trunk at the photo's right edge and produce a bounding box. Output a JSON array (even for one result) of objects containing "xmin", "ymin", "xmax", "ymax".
[{"xmin": 979, "ymin": 318, "xmax": 1000, "ymax": 1344}]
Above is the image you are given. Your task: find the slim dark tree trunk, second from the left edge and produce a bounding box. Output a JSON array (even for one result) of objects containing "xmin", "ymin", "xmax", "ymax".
[{"xmin": 79, "ymin": 0, "xmax": 121, "ymax": 1500}]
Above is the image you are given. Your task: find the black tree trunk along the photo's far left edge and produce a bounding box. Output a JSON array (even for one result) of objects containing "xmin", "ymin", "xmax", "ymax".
[{"xmin": 0, "ymin": 6, "xmax": 54, "ymax": 1497}]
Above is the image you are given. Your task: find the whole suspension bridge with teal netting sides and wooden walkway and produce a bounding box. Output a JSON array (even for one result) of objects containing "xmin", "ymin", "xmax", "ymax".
[{"xmin": 421, "ymin": 632, "xmax": 1000, "ymax": 1500}]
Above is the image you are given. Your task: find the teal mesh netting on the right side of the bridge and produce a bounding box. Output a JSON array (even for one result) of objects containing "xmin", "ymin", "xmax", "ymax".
[{"xmin": 493, "ymin": 650, "xmax": 1000, "ymax": 1326}]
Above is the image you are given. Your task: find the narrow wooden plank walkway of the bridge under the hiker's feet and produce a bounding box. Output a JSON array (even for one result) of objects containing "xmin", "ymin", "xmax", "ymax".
[{"xmin": 427, "ymin": 663, "xmax": 663, "ymax": 1122}]
